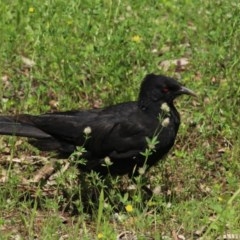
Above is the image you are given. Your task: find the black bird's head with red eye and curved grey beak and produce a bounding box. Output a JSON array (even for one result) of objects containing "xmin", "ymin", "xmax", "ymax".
[{"xmin": 139, "ymin": 74, "xmax": 197, "ymax": 107}]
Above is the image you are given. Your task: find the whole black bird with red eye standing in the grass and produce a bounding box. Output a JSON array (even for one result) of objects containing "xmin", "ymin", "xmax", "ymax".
[{"xmin": 0, "ymin": 74, "xmax": 195, "ymax": 176}]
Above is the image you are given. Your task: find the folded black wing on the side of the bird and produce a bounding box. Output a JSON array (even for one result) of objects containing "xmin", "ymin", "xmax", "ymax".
[{"xmin": 27, "ymin": 103, "xmax": 154, "ymax": 158}]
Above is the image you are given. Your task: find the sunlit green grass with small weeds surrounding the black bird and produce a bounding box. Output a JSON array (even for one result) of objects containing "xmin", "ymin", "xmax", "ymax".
[{"xmin": 0, "ymin": 0, "xmax": 240, "ymax": 239}]
